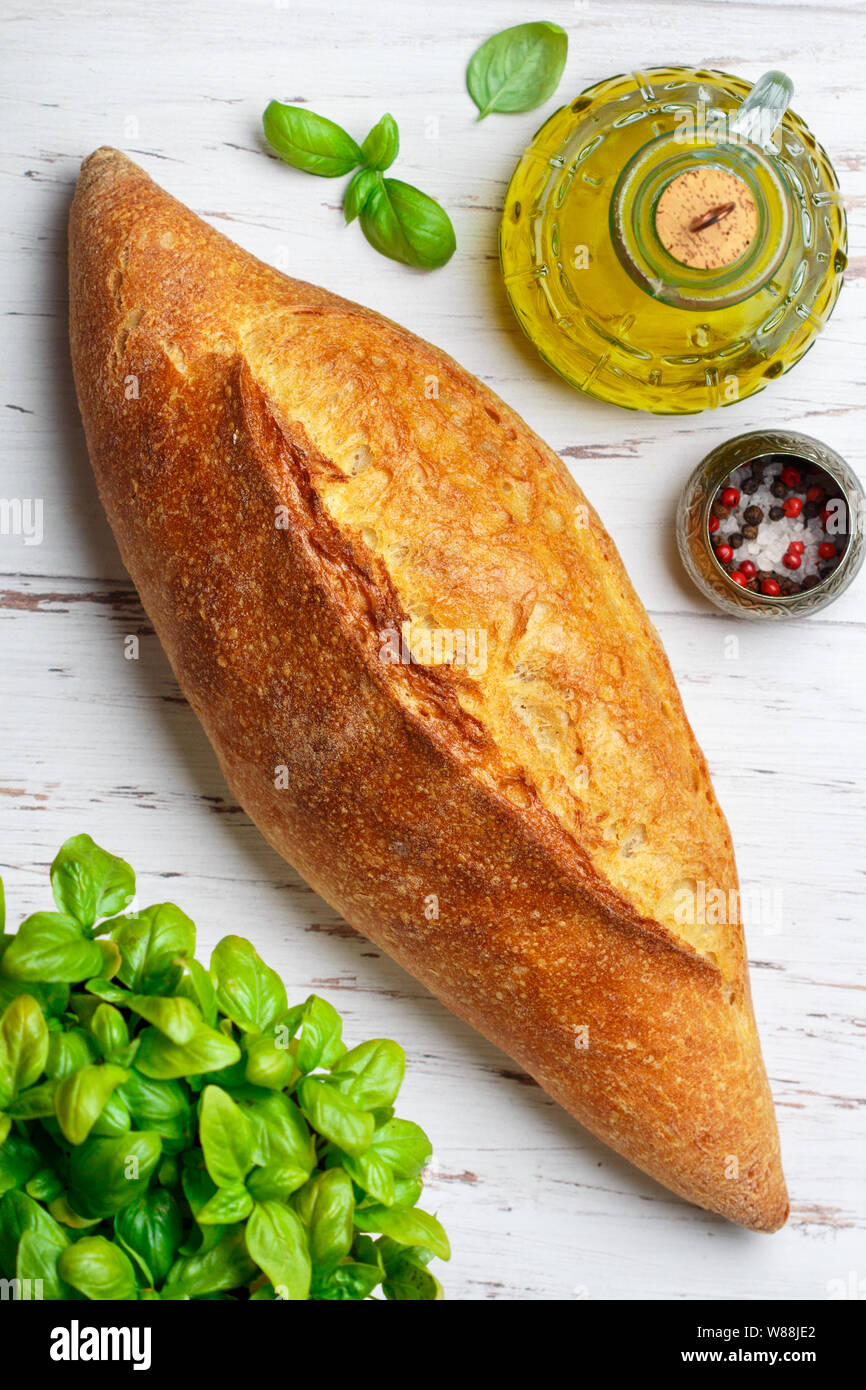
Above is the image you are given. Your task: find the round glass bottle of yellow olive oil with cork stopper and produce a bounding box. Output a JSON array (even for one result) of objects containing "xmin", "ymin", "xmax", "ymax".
[{"xmin": 500, "ymin": 68, "xmax": 847, "ymax": 414}]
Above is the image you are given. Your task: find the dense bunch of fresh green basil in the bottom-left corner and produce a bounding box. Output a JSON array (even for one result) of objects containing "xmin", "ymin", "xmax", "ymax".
[{"xmin": 0, "ymin": 835, "xmax": 450, "ymax": 1300}]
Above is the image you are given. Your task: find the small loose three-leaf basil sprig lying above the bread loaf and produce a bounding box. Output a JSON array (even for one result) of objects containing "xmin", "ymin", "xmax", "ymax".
[{"xmin": 263, "ymin": 101, "xmax": 457, "ymax": 270}]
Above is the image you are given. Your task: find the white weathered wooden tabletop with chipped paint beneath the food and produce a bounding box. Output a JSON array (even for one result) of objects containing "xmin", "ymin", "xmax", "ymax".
[{"xmin": 0, "ymin": 0, "xmax": 866, "ymax": 1300}]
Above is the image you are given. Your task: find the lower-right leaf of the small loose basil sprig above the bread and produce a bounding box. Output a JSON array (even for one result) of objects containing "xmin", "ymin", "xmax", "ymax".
[{"xmin": 360, "ymin": 174, "xmax": 457, "ymax": 270}]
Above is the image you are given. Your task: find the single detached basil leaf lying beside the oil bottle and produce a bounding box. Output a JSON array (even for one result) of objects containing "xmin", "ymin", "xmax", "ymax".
[{"xmin": 466, "ymin": 21, "xmax": 569, "ymax": 121}]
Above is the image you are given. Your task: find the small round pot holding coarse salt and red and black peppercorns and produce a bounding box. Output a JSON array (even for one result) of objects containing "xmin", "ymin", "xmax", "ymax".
[{"xmin": 677, "ymin": 430, "xmax": 865, "ymax": 621}]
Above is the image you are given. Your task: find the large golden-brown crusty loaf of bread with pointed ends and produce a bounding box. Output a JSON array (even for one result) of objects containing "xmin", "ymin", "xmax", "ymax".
[{"xmin": 70, "ymin": 149, "xmax": 787, "ymax": 1230}]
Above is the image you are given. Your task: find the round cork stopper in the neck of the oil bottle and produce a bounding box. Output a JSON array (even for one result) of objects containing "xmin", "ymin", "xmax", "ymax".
[{"xmin": 656, "ymin": 164, "xmax": 758, "ymax": 270}]
